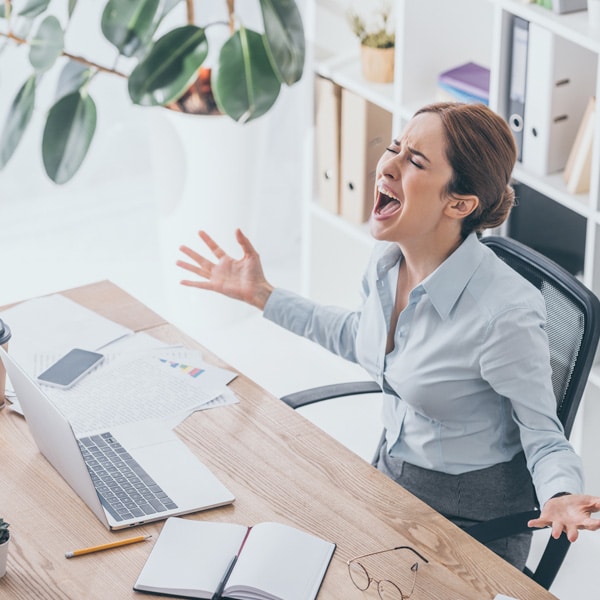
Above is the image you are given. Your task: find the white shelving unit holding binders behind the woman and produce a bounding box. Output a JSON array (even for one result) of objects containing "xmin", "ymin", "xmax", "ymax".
[{"xmin": 304, "ymin": 0, "xmax": 600, "ymax": 494}]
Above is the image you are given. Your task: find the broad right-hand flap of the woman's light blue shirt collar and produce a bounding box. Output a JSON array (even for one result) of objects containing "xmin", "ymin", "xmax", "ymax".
[{"xmin": 421, "ymin": 233, "xmax": 484, "ymax": 319}]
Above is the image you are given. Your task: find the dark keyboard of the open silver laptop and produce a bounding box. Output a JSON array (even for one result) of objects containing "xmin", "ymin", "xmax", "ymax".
[{"xmin": 79, "ymin": 433, "xmax": 177, "ymax": 521}]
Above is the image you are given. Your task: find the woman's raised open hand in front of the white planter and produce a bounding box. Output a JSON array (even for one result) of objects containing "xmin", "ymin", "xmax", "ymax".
[{"xmin": 177, "ymin": 229, "xmax": 273, "ymax": 310}]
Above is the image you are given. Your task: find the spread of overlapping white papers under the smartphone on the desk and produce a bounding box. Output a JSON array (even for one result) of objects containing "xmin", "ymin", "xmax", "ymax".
[{"xmin": 0, "ymin": 294, "xmax": 238, "ymax": 434}]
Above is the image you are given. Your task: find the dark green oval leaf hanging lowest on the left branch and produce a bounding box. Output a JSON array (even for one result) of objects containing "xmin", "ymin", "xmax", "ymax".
[{"xmin": 42, "ymin": 92, "xmax": 96, "ymax": 184}]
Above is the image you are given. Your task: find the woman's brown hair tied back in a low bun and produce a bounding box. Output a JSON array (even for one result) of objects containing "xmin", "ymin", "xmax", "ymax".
[{"xmin": 415, "ymin": 102, "xmax": 517, "ymax": 237}]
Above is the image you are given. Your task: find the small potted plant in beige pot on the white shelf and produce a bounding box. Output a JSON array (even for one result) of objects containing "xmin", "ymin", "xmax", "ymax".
[{"xmin": 348, "ymin": 0, "xmax": 396, "ymax": 83}]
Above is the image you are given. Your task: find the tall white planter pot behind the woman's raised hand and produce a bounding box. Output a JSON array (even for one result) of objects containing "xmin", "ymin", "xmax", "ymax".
[{"xmin": 149, "ymin": 109, "xmax": 264, "ymax": 334}]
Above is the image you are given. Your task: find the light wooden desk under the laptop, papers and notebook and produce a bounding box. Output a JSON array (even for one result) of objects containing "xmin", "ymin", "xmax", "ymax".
[{"xmin": 0, "ymin": 282, "xmax": 554, "ymax": 600}]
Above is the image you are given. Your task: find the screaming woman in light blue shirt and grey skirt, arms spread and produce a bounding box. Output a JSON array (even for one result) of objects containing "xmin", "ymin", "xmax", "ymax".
[{"xmin": 178, "ymin": 103, "xmax": 600, "ymax": 569}]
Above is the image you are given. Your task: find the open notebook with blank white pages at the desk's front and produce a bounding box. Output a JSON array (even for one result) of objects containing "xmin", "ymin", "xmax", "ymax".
[{"xmin": 133, "ymin": 517, "xmax": 335, "ymax": 600}]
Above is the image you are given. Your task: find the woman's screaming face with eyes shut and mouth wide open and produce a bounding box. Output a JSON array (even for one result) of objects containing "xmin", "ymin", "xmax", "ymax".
[{"xmin": 370, "ymin": 113, "xmax": 452, "ymax": 244}]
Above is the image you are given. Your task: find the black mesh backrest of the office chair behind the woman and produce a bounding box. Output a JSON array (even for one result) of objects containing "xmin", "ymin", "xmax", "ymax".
[{"xmin": 482, "ymin": 238, "xmax": 595, "ymax": 435}]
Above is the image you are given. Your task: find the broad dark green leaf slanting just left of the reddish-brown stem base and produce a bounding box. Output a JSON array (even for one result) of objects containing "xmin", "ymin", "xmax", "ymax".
[{"xmin": 128, "ymin": 25, "xmax": 208, "ymax": 106}]
